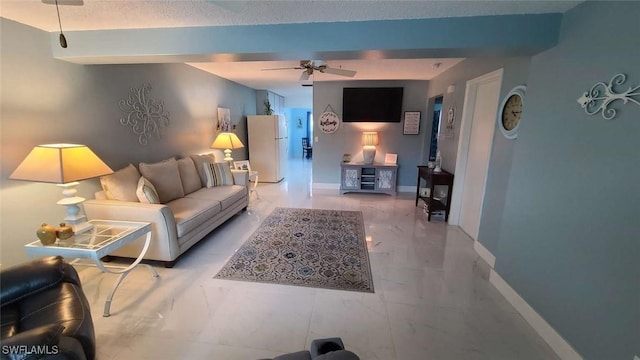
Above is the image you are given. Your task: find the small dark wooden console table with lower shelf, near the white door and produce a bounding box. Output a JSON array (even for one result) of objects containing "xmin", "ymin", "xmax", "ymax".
[{"xmin": 416, "ymin": 166, "xmax": 453, "ymax": 221}]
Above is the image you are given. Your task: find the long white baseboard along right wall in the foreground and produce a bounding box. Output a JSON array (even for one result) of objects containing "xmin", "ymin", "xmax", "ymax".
[{"xmin": 489, "ymin": 269, "xmax": 582, "ymax": 360}]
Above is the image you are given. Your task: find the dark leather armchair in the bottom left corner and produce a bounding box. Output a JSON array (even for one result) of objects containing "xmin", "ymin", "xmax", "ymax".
[{"xmin": 0, "ymin": 256, "xmax": 95, "ymax": 360}]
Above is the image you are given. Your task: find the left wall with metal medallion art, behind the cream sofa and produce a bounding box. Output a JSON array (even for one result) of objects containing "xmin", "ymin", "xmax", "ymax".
[{"xmin": 0, "ymin": 18, "xmax": 256, "ymax": 266}]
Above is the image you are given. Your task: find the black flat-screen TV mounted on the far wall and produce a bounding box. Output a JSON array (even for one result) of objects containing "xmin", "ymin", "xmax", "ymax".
[{"xmin": 342, "ymin": 87, "xmax": 404, "ymax": 122}]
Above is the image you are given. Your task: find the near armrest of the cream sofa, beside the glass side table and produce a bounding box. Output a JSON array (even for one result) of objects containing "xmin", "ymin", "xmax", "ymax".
[{"xmin": 83, "ymin": 200, "xmax": 179, "ymax": 261}]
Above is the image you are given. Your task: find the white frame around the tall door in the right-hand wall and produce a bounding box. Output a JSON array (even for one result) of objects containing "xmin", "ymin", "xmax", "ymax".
[{"xmin": 449, "ymin": 69, "xmax": 504, "ymax": 225}]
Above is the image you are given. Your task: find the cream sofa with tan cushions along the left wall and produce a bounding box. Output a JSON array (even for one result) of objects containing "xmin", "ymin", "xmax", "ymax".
[{"xmin": 84, "ymin": 154, "xmax": 249, "ymax": 267}]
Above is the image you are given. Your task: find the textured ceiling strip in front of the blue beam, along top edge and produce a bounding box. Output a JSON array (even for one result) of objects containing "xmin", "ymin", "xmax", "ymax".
[{"xmin": 0, "ymin": 0, "xmax": 579, "ymax": 31}]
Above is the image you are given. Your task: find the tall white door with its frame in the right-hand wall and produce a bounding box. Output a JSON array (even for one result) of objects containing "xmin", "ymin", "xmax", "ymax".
[{"xmin": 450, "ymin": 69, "xmax": 502, "ymax": 241}]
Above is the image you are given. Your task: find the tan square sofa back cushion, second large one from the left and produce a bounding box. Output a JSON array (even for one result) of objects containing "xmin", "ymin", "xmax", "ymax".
[{"xmin": 136, "ymin": 158, "xmax": 184, "ymax": 204}]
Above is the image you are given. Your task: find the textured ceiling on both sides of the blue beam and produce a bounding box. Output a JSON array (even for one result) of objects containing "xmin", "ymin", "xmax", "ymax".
[{"xmin": 0, "ymin": 0, "xmax": 580, "ymax": 107}]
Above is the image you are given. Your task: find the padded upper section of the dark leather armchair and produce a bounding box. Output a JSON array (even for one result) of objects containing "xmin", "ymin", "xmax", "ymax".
[{"xmin": 0, "ymin": 256, "xmax": 80, "ymax": 306}]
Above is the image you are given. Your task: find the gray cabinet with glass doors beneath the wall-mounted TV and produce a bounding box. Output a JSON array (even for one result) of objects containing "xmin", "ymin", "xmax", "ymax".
[{"xmin": 340, "ymin": 162, "xmax": 398, "ymax": 195}]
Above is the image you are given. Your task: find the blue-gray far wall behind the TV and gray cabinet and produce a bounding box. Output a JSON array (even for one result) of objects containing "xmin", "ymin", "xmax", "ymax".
[{"xmin": 313, "ymin": 81, "xmax": 431, "ymax": 189}]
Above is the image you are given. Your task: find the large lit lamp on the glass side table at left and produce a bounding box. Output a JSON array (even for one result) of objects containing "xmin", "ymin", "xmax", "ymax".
[{"xmin": 9, "ymin": 144, "xmax": 113, "ymax": 234}]
